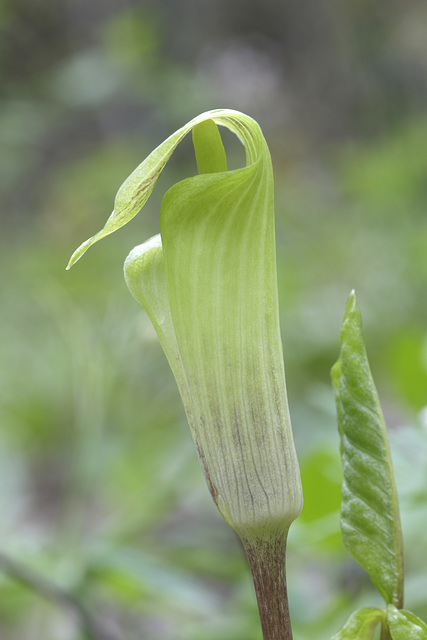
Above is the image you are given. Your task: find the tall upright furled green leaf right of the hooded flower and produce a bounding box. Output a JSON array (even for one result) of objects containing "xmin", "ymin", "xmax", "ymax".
[{"xmin": 332, "ymin": 292, "xmax": 403, "ymax": 608}]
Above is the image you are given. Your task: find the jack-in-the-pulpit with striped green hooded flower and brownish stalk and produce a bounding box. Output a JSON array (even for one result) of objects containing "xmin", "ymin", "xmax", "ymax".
[{"xmin": 69, "ymin": 109, "xmax": 302, "ymax": 640}]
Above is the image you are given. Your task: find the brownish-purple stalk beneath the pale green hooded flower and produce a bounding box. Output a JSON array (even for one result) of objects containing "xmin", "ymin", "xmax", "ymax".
[{"xmin": 243, "ymin": 532, "xmax": 292, "ymax": 640}]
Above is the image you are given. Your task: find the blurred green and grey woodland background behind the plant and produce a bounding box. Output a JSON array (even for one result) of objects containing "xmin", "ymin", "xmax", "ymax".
[{"xmin": 0, "ymin": 0, "xmax": 427, "ymax": 640}]
